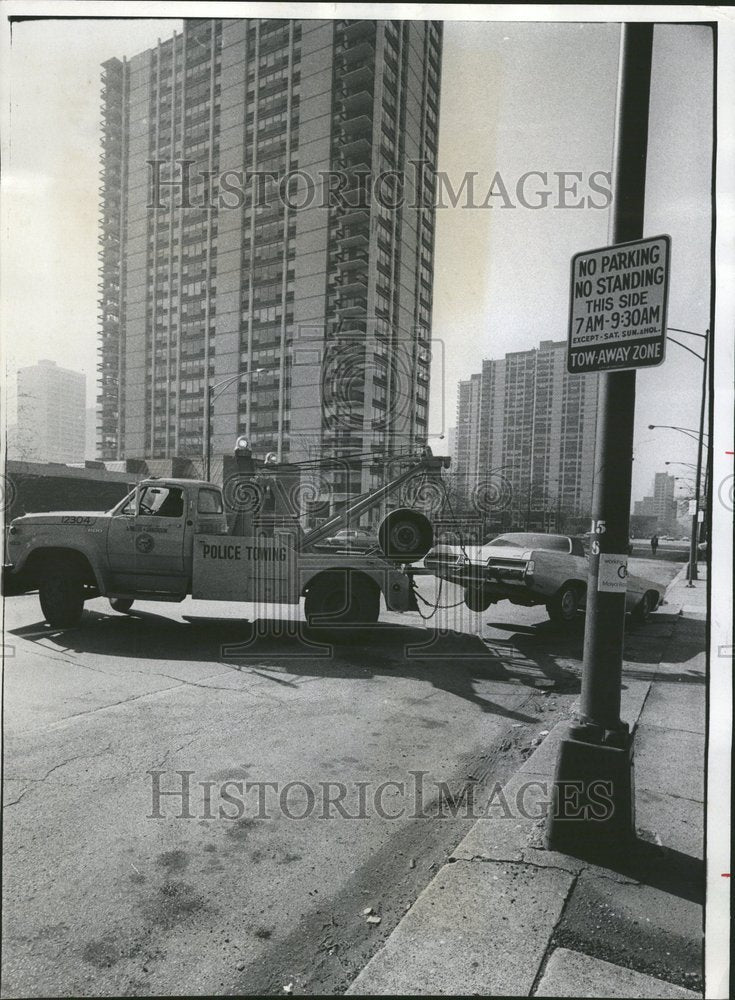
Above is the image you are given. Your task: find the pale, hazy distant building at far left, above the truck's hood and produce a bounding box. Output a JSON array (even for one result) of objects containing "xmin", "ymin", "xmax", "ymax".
[{"xmin": 15, "ymin": 361, "xmax": 87, "ymax": 462}]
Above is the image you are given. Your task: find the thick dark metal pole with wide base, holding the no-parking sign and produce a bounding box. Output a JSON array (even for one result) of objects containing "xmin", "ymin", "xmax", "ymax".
[{"xmin": 547, "ymin": 24, "xmax": 653, "ymax": 853}]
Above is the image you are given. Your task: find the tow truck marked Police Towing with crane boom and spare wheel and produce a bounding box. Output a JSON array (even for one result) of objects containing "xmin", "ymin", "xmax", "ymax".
[{"xmin": 4, "ymin": 439, "xmax": 450, "ymax": 628}]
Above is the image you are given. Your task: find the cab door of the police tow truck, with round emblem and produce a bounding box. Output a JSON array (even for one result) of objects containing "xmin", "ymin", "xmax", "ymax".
[{"xmin": 107, "ymin": 483, "xmax": 188, "ymax": 594}]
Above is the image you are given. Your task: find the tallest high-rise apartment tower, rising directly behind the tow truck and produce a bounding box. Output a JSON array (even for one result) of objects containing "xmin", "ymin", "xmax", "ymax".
[{"xmin": 99, "ymin": 18, "xmax": 442, "ymax": 498}]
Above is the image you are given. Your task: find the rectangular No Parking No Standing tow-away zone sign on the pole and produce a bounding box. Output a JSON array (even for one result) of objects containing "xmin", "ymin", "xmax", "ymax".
[{"xmin": 567, "ymin": 236, "xmax": 671, "ymax": 374}]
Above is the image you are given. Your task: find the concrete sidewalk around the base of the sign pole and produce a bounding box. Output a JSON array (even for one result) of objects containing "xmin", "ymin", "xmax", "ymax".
[{"xmin": 347, "ymin": 564, "xmax": 706, "ymax": 998}]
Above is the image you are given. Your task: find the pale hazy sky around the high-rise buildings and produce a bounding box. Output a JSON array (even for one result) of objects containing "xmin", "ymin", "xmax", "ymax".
[{"xmin": 2, "ymin": 12, "xmax": 712, "ymax": 497}]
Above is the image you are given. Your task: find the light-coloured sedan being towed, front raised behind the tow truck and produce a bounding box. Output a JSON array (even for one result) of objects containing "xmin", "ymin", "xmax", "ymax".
[{"xmin": 424, "ymin": 532, "xmax": 663, "ymax": 623}]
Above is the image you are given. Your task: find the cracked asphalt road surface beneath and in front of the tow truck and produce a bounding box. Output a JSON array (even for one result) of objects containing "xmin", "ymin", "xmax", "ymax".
[{"xmin": 2, "ymin": 563, "xmax": 678, "ymax": 996}]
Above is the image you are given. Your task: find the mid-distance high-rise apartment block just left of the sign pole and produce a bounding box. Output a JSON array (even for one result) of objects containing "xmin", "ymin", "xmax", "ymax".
[{"xmin": 455, "ymin": 340, "xmax": 598, "ymax": 529}]
